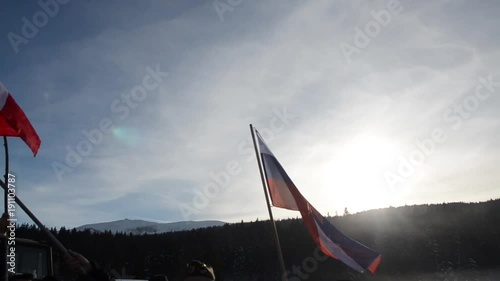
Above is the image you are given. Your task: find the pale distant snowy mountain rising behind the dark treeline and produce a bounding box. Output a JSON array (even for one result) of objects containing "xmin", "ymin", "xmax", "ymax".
[{"xmin": 76, "ymin": 219, "xmax": 225, "ymax": 234}]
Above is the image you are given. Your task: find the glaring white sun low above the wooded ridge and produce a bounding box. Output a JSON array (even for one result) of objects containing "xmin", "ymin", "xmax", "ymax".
[{"xmin": 322, "ymin": 135, "xmax": 398, "ymax": 212}]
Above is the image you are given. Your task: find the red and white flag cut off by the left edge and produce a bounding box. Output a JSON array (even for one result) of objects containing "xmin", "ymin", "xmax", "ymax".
[{"xmin": 0, "ymin": 83, "xmax": 41, "ymax": 156}]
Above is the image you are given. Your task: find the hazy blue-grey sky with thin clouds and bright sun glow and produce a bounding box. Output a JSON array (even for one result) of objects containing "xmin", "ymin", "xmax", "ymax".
[{"xmin": 0, "ymin": 0, "xmax": 500, "ymax": 227}]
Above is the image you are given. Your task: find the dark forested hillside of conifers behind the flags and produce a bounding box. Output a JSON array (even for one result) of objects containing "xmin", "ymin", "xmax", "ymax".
[{"xmin": 13, "ymin": 200, "xmax": 500, "ymax": 281}]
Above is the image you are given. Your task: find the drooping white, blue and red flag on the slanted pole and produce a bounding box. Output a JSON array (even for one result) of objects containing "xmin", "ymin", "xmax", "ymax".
[{"xmin": 257, "ymin": 132, "xmax": 382, "ymax": 274}]
